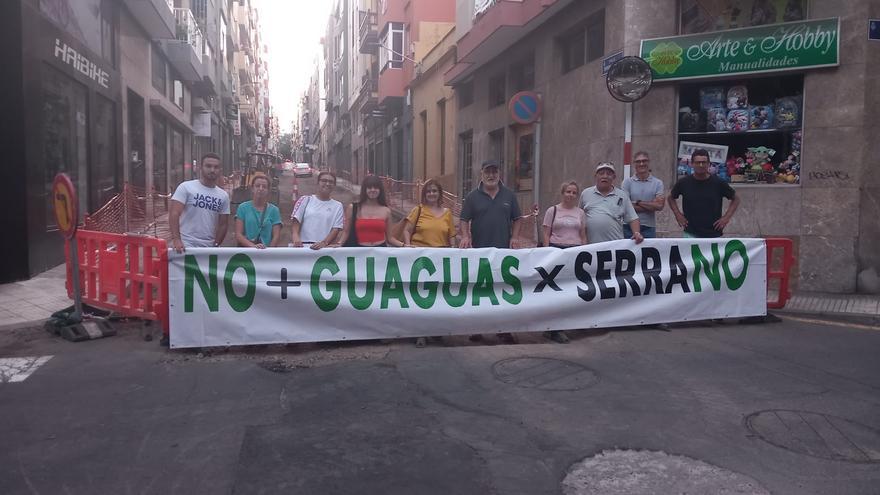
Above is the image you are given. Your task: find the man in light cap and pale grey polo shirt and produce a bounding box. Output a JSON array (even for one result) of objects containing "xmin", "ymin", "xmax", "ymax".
[{"xmin": 580, "ymin": 162, "xmax": 644, "ymax": 244}]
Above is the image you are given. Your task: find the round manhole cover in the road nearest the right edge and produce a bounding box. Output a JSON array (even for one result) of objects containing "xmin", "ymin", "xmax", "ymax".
[{"xmin": 746, "ymin": 409, "xmax": 880, "ymax": 463}]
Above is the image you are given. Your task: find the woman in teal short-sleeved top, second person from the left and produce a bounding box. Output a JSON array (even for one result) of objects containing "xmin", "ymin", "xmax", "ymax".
[{"xmin": 235, "ymin": 174, "xmax": 281, "ymax": 249}]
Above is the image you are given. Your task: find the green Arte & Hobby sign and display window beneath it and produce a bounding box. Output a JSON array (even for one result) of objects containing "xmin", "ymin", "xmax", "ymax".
[{"xmin": 641, "ymin": 18, "xmax": 840, "ymax": 187}]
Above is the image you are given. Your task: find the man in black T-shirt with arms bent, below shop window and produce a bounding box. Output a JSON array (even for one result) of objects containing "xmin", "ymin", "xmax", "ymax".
[{"xmin": 669, "ymin": 149, "xmax": 739, "ymax": 237}]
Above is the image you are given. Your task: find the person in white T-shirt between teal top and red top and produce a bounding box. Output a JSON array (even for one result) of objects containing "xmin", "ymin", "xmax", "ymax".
[{"xmin": 290, "ymin": 172, "xmax": 344, "ymax": 249}]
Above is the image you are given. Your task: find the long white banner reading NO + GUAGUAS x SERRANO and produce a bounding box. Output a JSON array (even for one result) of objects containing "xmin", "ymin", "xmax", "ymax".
[{"xmin": 168, "ymin": 238, "xmax": 767, "ymax": 348}]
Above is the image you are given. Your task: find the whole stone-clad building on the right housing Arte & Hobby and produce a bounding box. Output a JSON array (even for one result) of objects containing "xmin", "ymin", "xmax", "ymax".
[{"xmin": 445, "ymin": 0, "xmax": 880, "ymax": 292}]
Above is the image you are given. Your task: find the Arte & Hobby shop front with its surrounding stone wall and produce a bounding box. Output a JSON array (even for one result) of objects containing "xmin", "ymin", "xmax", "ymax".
[{"xmin": 634, "ymin": 0, "xmax": 880, "ymax": 293}]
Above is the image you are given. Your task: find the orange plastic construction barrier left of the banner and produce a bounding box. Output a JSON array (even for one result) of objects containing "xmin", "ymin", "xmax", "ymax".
[{"xmin": 65, "ymin": 230, "xmax": 169, "ymax": 335}]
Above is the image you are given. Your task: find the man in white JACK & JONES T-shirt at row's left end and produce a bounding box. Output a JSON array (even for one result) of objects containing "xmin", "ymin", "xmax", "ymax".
[{"xmin": 168, "ymin": 153, "xmax": 229, "ymax": 253}]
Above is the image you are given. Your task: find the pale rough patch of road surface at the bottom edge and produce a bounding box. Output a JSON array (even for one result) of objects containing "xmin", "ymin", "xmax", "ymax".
[{"xmin": 562, "ymin": 450, "xmax": 770, "ymax": 495}]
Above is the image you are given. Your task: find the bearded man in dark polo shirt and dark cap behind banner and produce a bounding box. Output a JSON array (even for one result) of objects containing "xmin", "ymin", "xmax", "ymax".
[{"xmin": 458, "ymin": 160, "xmax": 522, "ymax": 248}]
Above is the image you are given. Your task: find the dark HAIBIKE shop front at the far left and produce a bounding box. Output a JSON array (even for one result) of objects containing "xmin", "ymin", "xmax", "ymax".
[{"xmin": 0, "ymin": 0, "xmax": 123, "ymax": 281}]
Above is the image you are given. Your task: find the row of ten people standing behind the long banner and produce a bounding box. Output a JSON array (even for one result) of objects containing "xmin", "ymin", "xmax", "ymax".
[{"xmin": 169, "ymin": 149, "xmax": 740, "ymax": 345}]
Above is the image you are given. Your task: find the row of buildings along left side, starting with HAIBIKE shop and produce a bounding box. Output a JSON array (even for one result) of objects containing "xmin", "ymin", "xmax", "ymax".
[{"xmin": 0, "ymin": 0, "xmax": 271, "ymax": 281}]
